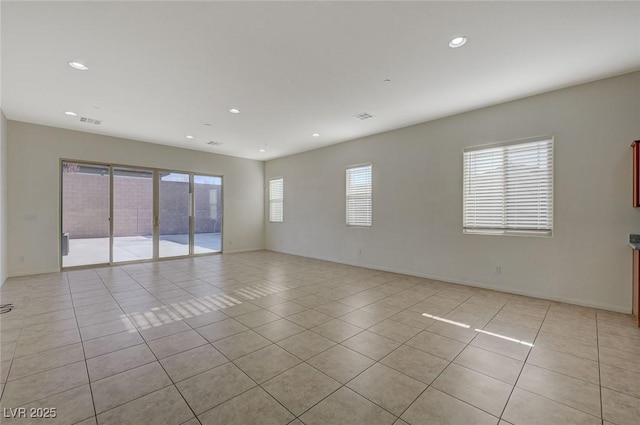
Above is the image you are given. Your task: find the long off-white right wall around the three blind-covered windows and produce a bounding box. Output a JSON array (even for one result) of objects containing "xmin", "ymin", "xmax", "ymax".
[{"xmin": 265, "ymin": 72, "xmax": 640, "ymax": 312}]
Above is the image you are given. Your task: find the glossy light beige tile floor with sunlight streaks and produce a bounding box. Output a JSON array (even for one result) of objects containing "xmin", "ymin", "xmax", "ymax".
[{"xmin": 0, "ymin": 251, "xmax": 640, "ymax": 425}]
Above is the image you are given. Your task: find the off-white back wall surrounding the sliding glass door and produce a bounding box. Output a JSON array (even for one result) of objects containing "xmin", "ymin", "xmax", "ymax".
[{"xmin": 7, "ymin": 120, "xmax": 264, "ymax": 276}]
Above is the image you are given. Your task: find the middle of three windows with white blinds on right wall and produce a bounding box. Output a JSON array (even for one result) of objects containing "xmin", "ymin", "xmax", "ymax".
[{"xmin": 347, "ymin": 164, "xmax": 372, "ymax": 227}]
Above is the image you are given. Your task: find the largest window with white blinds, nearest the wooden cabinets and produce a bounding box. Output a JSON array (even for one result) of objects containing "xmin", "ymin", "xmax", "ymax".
[{"xmin": 463, "ymin": 136, "xmax": 553, "ymax": 236}]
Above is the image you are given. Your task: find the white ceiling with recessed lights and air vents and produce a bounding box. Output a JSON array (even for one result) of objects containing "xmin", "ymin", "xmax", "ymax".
[{"xmin": 1, "ymin": 1, "xmax": 640, "ymax": 160}]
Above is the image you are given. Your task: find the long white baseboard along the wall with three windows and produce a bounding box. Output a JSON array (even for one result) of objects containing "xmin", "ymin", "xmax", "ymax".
[{"xmin": 267, "ymin": 249, "xmax": 631, "ymax": 314}]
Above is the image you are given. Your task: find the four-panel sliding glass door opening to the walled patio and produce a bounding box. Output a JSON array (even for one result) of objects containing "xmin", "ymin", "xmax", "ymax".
[{"xmin": 60, "ymin": 161, "xmax": 222, "ymax": 267}]
